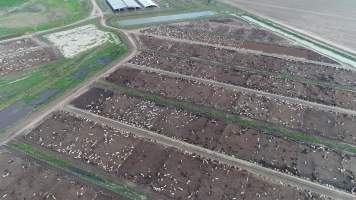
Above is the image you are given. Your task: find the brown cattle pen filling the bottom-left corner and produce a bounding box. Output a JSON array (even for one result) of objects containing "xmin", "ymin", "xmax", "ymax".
[{"xmin": 0, "ymin": 149, "xmax": 120, "ymax": 200}]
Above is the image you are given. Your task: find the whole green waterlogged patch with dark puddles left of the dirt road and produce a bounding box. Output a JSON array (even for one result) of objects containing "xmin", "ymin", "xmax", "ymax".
[{"xmin": 0, "ymin": 27, "xmax": 128, "ymax": 133}]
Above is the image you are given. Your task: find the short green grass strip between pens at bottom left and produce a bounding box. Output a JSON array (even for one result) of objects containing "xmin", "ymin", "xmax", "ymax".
[{"xmin": 9, "ymin": 142, "xmax": 153, "ymax": 200}]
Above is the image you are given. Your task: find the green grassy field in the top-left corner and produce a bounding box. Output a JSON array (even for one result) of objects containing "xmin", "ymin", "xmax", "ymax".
[{"xmin": 0, "ymin": 0, "xmax": 91, "ymax": 38}]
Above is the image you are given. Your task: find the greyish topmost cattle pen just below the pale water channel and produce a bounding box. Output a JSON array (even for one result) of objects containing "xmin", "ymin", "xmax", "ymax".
[{"xmin": 141, "ymin": 18, "xmax": 293, "ymax": 47}]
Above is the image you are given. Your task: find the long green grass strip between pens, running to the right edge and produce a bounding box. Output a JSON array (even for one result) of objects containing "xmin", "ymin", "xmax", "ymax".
[{"xmin": 97, "ymin": 81, "xmax": 356, "ymax": 154}]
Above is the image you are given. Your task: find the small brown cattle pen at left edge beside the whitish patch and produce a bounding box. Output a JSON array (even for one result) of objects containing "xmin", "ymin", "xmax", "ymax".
[{"xmin": 0, "ymin": 38, "xmax": 59, "ymax": 76}]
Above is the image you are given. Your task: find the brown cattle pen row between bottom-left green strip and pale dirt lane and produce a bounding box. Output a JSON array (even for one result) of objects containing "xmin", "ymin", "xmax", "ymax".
[{"xmin": 25, "ymin": 112, "xmax": 330, "ymax": 200}]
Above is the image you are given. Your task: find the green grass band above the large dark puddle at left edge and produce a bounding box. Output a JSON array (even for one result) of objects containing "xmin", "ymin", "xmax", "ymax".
[{"xmin": 0, "ymin": 40, "xmax": 127, "ymax": 110}]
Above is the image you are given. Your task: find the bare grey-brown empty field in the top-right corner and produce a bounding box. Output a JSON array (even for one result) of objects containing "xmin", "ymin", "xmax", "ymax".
[{"xmin": 224, "ymin": 0, "xmax": 356, "ymax": 52}]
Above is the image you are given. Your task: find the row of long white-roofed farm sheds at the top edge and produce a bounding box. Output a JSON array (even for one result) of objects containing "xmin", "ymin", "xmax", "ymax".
[{"xmin": 106, "ymin": 0, "xmax": 158, "ymax": 11}]
